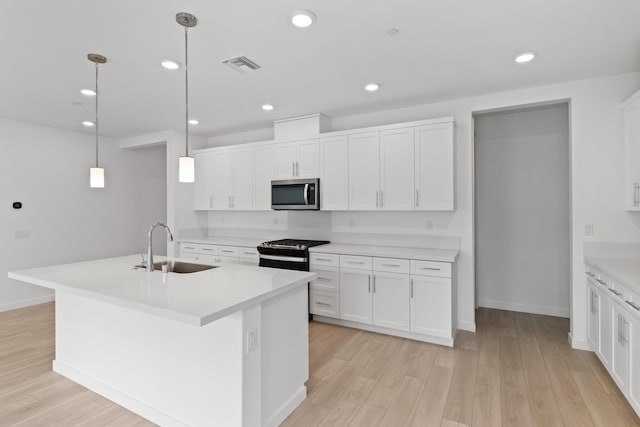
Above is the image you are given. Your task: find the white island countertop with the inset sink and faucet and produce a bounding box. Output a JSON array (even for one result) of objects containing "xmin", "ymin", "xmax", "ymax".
[{"xmin": 9, "ymin": 255, "xmax": 316, "ymax": 326}]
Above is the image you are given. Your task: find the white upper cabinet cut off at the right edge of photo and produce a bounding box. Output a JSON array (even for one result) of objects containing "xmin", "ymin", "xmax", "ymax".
[{"xmin": 623, "ymin": 91, "xmax": 640, "ymax": 212}]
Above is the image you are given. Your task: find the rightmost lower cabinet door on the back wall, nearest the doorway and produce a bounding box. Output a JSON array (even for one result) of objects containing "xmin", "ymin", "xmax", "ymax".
[{"xmin": 410, "ymin": 276, "xmax": 452, "ymax": 338}]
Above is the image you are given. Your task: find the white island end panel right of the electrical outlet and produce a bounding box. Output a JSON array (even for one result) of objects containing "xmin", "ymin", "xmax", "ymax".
[{"xmin": 261, "ymin": 283, "xmax": 309, "ymax": 427}]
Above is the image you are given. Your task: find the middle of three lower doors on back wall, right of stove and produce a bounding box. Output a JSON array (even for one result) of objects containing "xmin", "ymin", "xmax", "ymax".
[{"xmin": 373, "ymin": 272, "xmax": 410, "ymax": 331}]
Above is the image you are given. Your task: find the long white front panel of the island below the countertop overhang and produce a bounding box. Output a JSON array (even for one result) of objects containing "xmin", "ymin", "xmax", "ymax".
[{"xmin": 54, "ymin": 290, "xmax": 244, "ymax": 426}]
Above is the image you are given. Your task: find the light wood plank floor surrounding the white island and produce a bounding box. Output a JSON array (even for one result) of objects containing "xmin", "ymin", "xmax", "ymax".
[{"xmin": 0, "ymin": 303, "xmax": 640, "ymax": 427}]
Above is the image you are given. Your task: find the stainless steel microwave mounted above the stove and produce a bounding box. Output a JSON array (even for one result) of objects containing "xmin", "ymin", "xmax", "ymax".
[{"xmin": 271, "ymin": 178, "xmax": 320, "ymax": 211}]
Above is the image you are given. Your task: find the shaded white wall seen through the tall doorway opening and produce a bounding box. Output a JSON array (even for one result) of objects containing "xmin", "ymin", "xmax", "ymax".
[{"xmin": 474, "ymin": 103, "xmax": 571, "ymax": 317}]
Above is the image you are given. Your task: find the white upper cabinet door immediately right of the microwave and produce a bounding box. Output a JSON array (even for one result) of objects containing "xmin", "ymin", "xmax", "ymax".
[{"xmin": 320, "ymin": 135, "xmax": 349, "ymax": 211}]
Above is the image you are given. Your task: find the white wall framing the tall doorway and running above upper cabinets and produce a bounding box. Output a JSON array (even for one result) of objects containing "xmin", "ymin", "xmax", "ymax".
[{"xmin": 200, "ymin": 73, "xmax": 640, "ymax": 346}]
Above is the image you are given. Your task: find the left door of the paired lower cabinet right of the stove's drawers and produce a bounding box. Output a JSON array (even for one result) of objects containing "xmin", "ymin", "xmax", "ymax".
[{"xmin": 340, "ymin": 268, "xmax": 373, "ymax": 324}]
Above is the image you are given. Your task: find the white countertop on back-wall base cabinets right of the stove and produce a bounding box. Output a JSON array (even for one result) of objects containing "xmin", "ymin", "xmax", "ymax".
[{"xmin": 309, "ymin": 243, "xmax": 458, "ymax": 262}]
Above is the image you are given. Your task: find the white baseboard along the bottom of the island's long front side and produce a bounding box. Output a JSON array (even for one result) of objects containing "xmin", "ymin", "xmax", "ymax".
[{"xmin": 53, "ymin": 360, "xmax": 188, "ymax": 427}]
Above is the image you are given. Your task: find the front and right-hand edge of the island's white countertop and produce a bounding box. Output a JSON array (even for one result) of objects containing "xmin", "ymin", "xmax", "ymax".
[{"xmin": 7, "ymin": 272, "xmax": 317, "ymax": 326}]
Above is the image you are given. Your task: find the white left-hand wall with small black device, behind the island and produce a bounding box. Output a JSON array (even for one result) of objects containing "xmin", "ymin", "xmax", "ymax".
[{"xmin": 0, "ymin": 119, "xmax": 166, "ymax": 311}]
